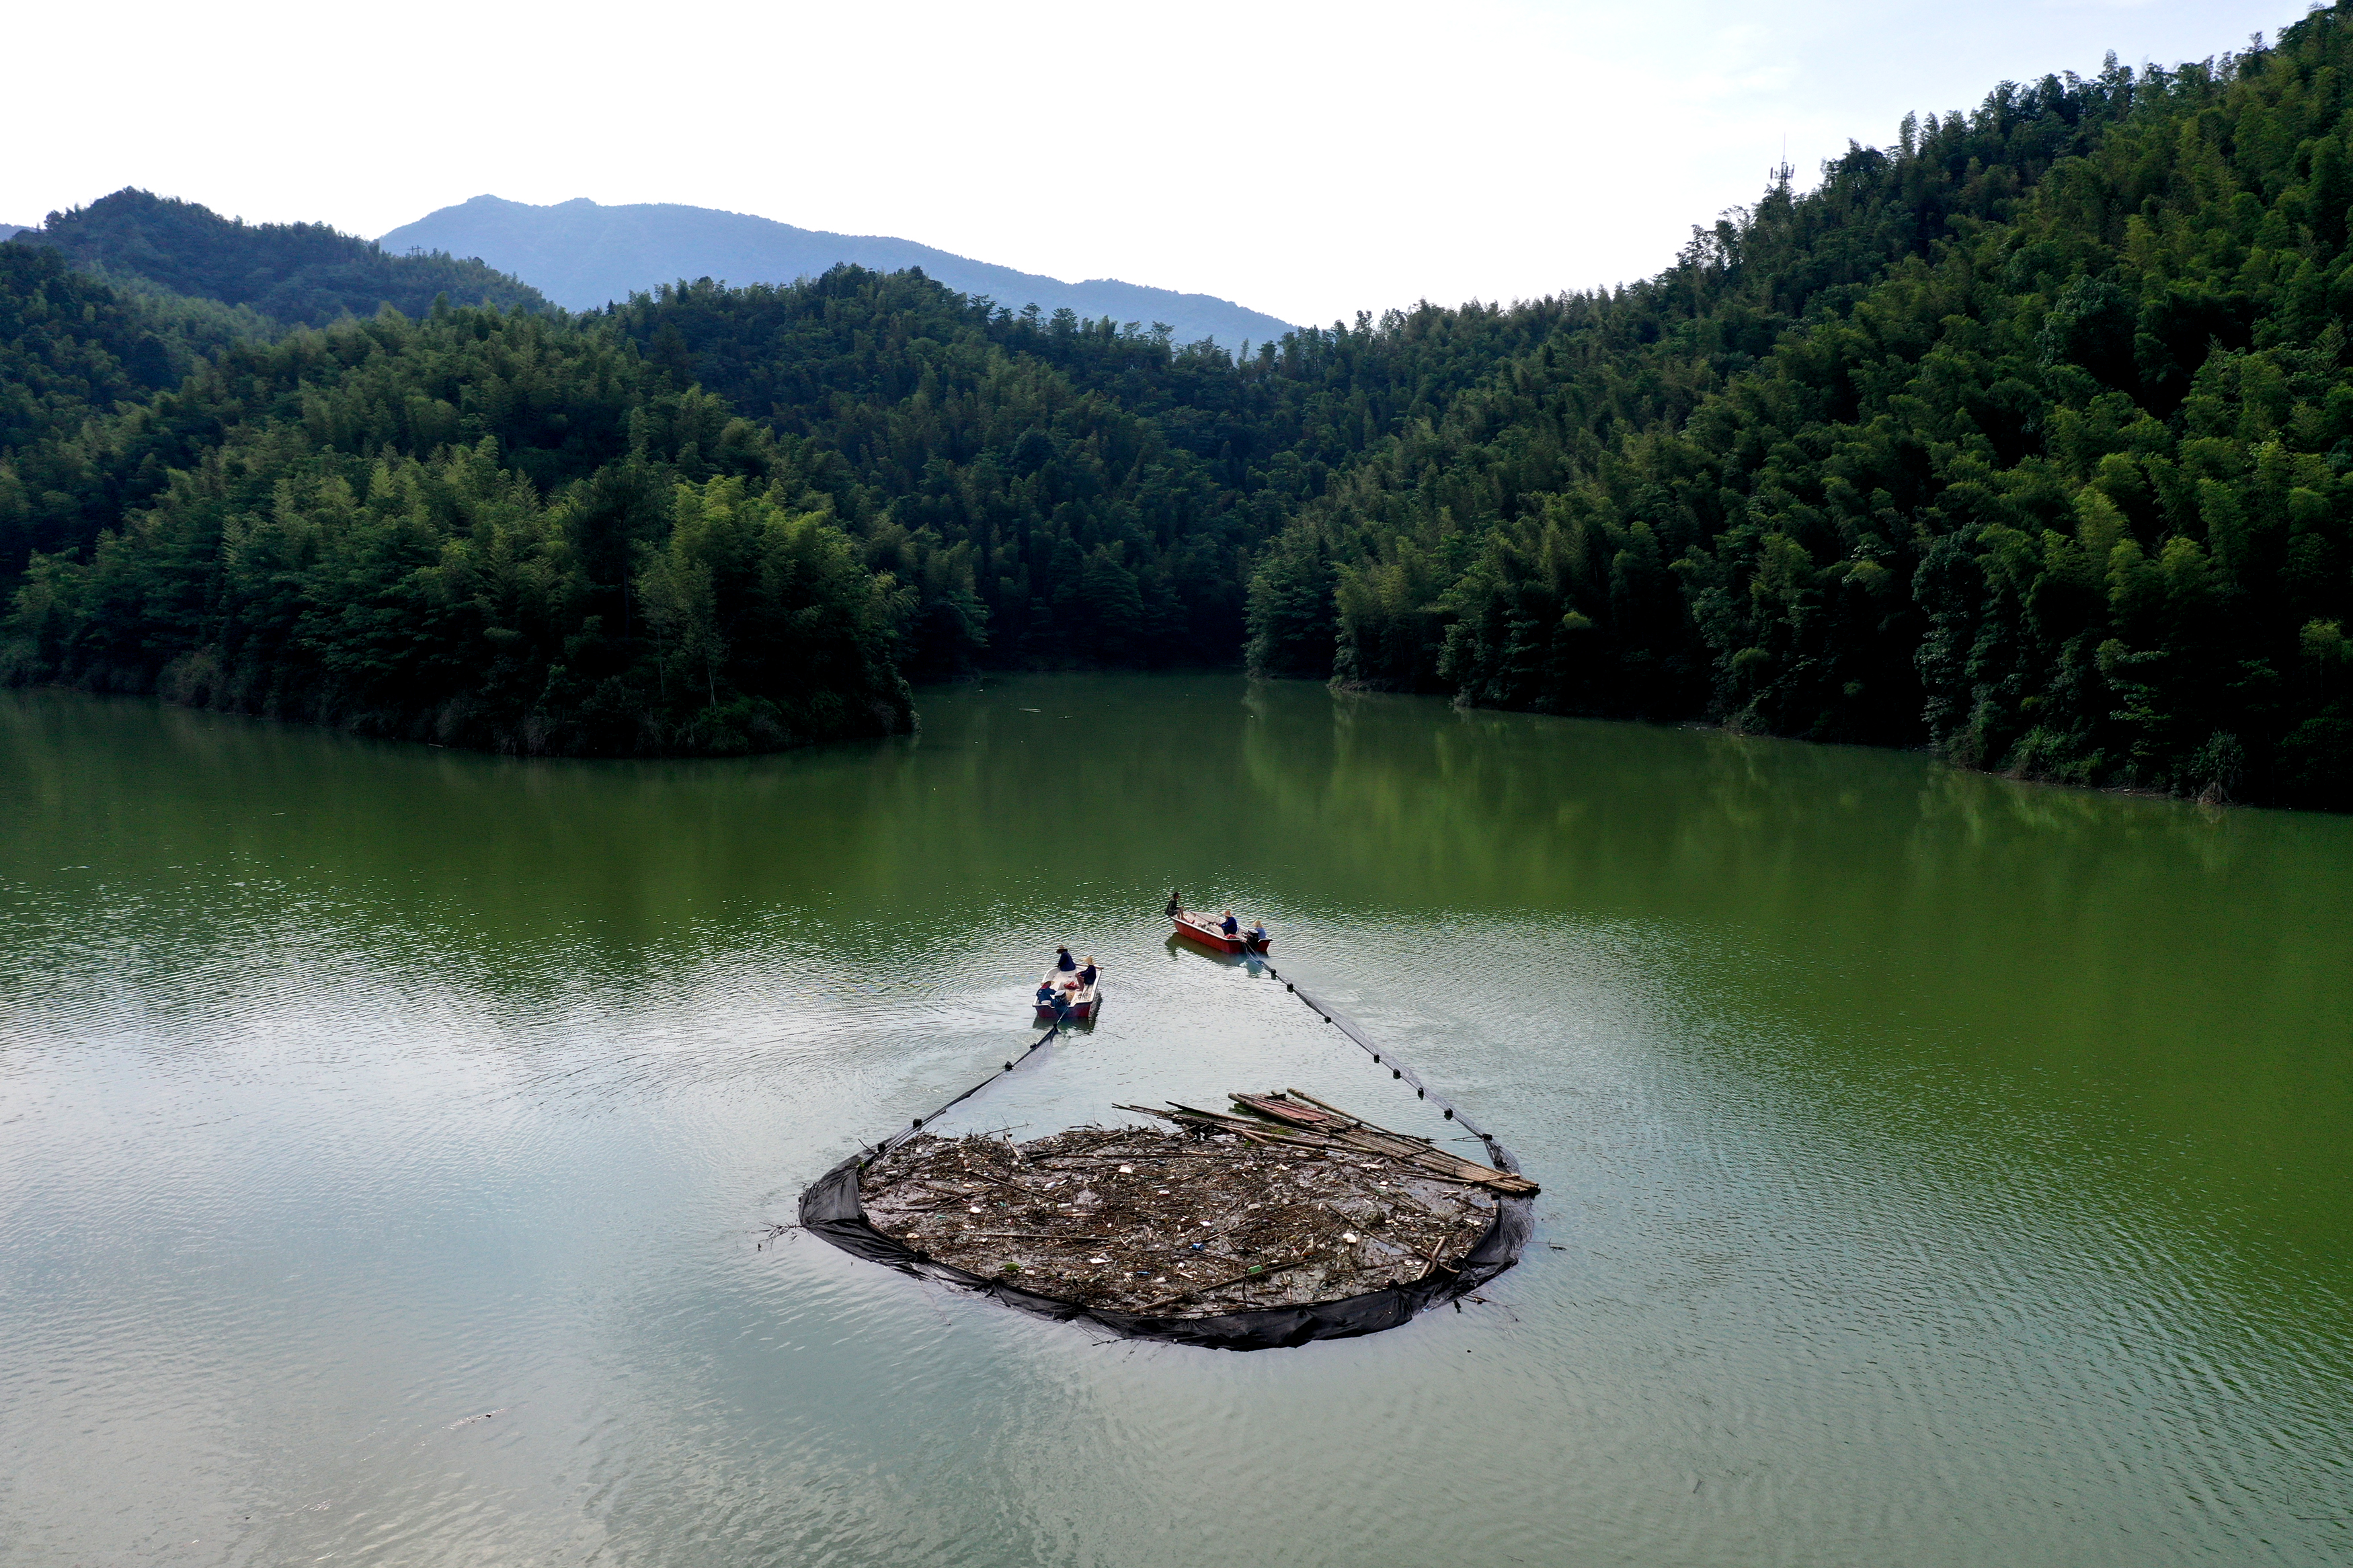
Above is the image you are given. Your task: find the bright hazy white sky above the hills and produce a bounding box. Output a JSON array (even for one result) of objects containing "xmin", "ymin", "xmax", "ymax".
[{"xmin": 0, "ymin": 0, "xmax": 2304, "ymax": 322}]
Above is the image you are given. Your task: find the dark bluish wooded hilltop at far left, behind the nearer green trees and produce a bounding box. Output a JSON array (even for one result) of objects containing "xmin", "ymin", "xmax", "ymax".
[{"xmin": 14, "ymin": 190, "xmax": 546, "ymax": 327}]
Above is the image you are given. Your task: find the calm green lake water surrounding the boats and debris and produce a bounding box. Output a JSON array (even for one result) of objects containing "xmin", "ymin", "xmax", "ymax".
[{"xmin": 0, "ymin": 677, "xmax": 2353, "ymax": 1568}]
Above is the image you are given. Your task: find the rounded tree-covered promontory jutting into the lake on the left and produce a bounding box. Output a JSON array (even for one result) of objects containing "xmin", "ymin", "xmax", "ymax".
[{"xmin": 0, "ymin": 308, "xmax": 911, "ymax": 752}]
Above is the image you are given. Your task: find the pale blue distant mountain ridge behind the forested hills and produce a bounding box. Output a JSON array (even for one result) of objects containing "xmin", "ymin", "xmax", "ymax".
[{"xmin": 379, "ymin": 195, "xmax": 1292, "ymax": 350}]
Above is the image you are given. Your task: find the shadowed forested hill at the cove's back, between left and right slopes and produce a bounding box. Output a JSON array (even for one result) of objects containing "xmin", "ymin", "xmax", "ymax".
[{"xmin": 607, "ymin": 268, "xmax": 1551, "ymax": 675}]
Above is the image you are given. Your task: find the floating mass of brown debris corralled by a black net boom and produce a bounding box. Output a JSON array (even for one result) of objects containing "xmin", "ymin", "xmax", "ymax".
[{"xmin": 803, "ymin": 1091, "xmax": 1534, "ymax": 1350}]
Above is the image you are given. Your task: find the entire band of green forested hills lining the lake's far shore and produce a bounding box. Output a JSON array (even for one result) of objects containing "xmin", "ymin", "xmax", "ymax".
[{"xmin": 0, "ymin": 9, "xmax": 2353, "ymax": 809}]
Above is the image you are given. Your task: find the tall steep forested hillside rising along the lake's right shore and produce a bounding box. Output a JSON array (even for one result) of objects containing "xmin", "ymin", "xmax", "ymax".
[{"xmin": 1252, "ymin": 9, "xmax": 2353, "ymax": 807}]
